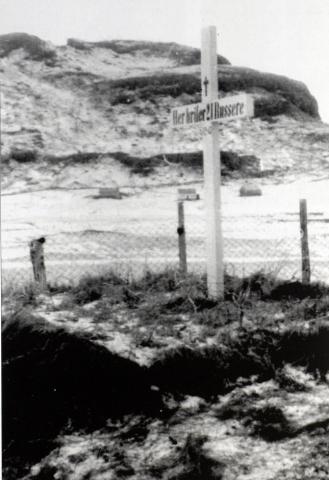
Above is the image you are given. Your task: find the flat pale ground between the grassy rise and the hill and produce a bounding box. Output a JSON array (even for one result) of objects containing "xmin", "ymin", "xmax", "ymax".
[{"xmin": 2, "ymin": 179, "xmax": 329, "ymax": 284}]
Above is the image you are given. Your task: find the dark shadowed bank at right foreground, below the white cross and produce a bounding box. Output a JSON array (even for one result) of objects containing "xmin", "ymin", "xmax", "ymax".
[{"xmin": 150, "ymin": 324, "xmax": 329, "ymax": 400}]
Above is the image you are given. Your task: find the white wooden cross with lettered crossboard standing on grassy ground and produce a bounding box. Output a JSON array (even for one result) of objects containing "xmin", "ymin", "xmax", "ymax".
[{"xmin": 171, "ymin": 26, "xmax": 254, "ymax": 298}]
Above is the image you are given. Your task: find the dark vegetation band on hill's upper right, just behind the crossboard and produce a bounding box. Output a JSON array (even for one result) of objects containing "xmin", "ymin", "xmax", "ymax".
[{"xmin": 108, "ymin": 66, "xmax": 319, "ymax": 118}]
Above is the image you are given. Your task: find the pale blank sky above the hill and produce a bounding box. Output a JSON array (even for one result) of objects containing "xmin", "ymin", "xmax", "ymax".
[{"xmin": 0, "ymin": 0, "xmax": 329, "ymax": 123}]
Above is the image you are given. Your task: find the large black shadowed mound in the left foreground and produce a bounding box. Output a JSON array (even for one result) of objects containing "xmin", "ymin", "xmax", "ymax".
[{"xmin": 2, "ymin": 311, "xmax": 161, "ymax": 462}]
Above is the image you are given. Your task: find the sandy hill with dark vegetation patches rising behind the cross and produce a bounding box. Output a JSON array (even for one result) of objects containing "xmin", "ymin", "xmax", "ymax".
[{"xmin": 0, "ymin": 33, "xmax": 329, "ymax": 188}]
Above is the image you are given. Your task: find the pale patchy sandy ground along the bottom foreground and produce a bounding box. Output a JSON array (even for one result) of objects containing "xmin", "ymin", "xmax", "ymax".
[{"xmin": 28, "ymin": 381, "xmax": 328, "ymax": 480}]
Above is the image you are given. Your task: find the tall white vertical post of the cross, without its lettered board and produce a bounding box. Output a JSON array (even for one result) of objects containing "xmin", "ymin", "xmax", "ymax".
[{"xmin": 201, "ymin": 26, "xmax": 224, "ymax": 299}]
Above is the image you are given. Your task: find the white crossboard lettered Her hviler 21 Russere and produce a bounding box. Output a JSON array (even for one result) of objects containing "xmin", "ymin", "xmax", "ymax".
[{"xmin": 171, "ymin": 93, "xmax": 254, "ymax": 127}]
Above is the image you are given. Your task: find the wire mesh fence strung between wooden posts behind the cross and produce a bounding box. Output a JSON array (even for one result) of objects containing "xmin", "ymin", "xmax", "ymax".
[{"xmin": 2, "ymin": 189, "xmax": 329, "ymax": 287}]
